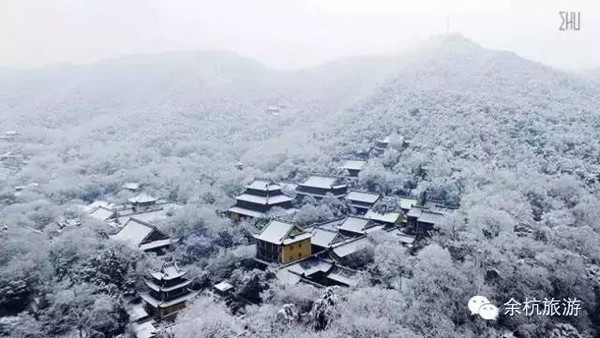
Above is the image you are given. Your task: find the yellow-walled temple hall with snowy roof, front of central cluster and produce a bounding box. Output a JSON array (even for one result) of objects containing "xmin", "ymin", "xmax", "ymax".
[{"xmin": 254, "ymin": 220, "xmax": 313, "ymax": 264}]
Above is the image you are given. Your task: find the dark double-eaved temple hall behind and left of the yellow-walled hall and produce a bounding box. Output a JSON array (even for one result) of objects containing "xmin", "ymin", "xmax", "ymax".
[{"xmin": 227, "ymin": 180, "xmax": 294, "ymax": 220}]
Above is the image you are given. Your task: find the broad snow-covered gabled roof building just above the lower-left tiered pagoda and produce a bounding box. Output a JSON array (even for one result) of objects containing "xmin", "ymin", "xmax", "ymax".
[{"xmin": 111, "ymin": 217, "xmax": 177, "ymax": 253}]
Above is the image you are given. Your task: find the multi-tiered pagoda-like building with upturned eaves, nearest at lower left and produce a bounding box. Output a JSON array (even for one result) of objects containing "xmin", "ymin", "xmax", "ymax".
[{"xmin": 140, "ymin": 263, "xmax": 198, "ymax": 320}]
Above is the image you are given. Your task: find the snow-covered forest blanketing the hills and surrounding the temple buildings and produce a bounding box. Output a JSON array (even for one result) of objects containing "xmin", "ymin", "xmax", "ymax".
[{"xmin": 0, "ymin": 37, "xmax": 600, "ymax": 337}]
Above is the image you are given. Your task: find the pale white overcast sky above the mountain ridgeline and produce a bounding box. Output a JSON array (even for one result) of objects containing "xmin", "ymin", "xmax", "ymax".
[{"xmin": 0, "ymin": 0, "xmax": 600, "ymax": 69}]
